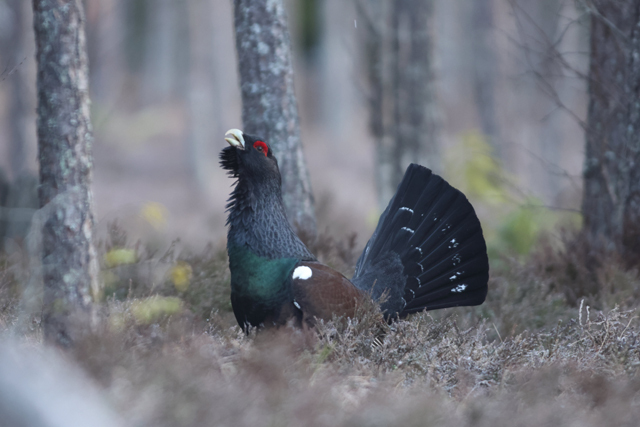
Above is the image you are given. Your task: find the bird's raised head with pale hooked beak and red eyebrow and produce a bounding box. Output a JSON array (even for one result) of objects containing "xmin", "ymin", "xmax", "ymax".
[{"xmin": 220, "ymin": 129, "xmax": 280, "ymax": 182}]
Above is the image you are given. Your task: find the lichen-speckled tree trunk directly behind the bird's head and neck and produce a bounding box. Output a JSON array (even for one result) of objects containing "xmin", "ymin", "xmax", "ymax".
[{"xmin": 234, "ymin": 0, "xmax": 316, "ymax": 236}]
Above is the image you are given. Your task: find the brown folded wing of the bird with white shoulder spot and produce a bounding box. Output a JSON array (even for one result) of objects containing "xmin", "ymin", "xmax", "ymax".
[{"xmin": 293, "ymin": 262, "xmax": 368, "ymax": 322}]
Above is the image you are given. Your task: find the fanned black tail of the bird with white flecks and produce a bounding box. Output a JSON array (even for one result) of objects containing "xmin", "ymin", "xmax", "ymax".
[{"xmin": 352, "ymin": 164, "xmax": 489, "ymax": 317}]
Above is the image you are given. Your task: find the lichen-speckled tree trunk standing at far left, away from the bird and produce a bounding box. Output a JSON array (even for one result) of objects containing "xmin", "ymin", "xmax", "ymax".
[{"xmin": 33, "ymin": 0, "xmax": 100, "ymax": 346}]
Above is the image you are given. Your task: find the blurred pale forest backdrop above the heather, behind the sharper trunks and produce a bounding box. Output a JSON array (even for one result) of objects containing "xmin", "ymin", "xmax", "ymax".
[{"xmin": 0, "ymin": 0, "xmax": 632, "ymax": 264}]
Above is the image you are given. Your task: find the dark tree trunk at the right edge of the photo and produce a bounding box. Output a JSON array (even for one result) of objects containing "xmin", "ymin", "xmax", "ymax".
[{"xmin": 582, "ymin": 0, "xmax": 640, "ymax": 264}]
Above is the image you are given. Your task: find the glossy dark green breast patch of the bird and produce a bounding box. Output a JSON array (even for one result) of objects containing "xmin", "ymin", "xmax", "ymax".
[{"xmin": 227, "ymin": 245, "xmax": 298, "ymax": 302}]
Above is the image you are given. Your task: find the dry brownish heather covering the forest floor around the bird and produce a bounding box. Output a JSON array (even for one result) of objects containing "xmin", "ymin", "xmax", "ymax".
[{"xmin": 0, "ymin": 231, "xmax": 640, "ymax": 427}]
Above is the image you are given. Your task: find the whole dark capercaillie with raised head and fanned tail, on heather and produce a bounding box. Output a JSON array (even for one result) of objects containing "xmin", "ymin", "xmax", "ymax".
[{"xmin": 220, "ymin": 129, "xmax": 489, "ymax": 331}]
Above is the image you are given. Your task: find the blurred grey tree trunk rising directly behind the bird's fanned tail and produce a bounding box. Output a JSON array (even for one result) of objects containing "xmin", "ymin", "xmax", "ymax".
[{"xmin": 358, "ymin": 0, "xmax": 438, "ymax": 209}]
